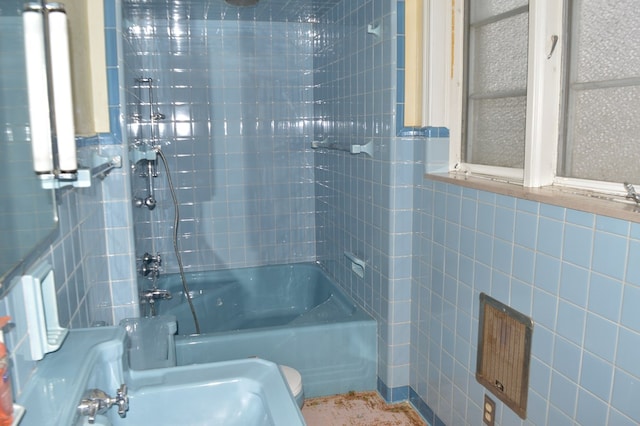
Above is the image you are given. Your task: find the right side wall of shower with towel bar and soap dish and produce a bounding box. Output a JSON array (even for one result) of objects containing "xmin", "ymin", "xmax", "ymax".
[{"xmin": 314, "ymin": 0, "xmax": 414, "ymax": 400}]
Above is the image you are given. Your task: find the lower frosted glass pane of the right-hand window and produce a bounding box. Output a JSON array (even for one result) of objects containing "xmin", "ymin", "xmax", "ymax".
[{"xmin": 567, "ymin": 86, "xmax": 640, "ymax": 183}]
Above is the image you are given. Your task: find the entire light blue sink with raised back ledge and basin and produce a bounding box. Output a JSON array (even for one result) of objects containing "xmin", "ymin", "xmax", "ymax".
[{"xmin": 17, "ymin": 327, "xmax": 305, "ymax": 426}]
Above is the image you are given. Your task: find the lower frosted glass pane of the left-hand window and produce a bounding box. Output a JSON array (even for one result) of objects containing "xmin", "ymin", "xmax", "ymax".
[{"xmin": 466, "ymin": 96, "xmax": 527, "ymax": 169}]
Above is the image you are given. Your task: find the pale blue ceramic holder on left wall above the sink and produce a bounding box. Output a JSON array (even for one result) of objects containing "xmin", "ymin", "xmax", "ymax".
[{"xmin": 21, "ymin": 263, "xmax": 69, "ymax": 361}]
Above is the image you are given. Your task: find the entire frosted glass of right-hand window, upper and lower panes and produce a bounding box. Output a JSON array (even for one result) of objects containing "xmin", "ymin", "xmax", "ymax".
[{"xmin": 558, "ymin": 0, "xmax": 640, "ymax": 184}]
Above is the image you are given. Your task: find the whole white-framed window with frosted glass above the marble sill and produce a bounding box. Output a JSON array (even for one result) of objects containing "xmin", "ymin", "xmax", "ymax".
[{"xmin": 451, "ymin": 0, "xmax": 640, "ymax": 194}]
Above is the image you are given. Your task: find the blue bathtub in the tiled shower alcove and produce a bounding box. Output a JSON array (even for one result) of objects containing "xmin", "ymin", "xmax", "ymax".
[{"xmin": 156, "ymin": 263, "xmax": 377, "ymax": 397}]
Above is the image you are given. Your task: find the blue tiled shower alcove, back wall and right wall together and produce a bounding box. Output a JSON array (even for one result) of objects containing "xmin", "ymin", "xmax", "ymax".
[{"xmin": 125, "ymin": 0, "xmax": 414, "ymax": 400}]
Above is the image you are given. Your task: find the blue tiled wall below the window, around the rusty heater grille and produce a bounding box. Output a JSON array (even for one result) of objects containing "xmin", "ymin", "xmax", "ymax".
[{"xmin": 410, "ymin": 149, "xmax": 640, "ymax": 425}]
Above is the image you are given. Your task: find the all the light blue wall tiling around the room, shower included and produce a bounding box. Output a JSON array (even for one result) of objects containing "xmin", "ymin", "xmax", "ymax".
[{"xmin": 6, "ymin": 0, "xmax": 640, "ymax": 425}]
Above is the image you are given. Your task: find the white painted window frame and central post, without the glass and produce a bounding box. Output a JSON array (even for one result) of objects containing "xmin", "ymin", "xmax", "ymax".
[{"xmin": 446, "ymin": 0, "xmax": 626, "ymax": 197}]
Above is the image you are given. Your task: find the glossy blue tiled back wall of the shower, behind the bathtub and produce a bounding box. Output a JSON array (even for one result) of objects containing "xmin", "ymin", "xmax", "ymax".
[{"xmin": 123, "ymin": 13, "xmax": 315, "ymax": 273}]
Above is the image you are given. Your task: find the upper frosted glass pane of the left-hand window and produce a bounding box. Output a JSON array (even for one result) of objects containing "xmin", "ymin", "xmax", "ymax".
[{"xmin": 469, "ymin": 13, "xmax": 528, "ymax": 94}]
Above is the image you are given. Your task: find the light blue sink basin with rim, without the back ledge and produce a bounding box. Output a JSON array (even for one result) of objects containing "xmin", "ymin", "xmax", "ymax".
[{"xmin": 80, "ymin": 359, "xmax": 305, "ymax": 426}]
